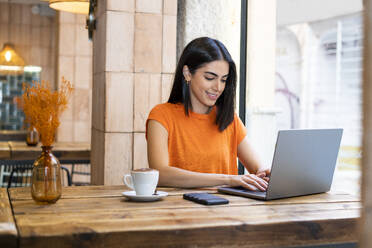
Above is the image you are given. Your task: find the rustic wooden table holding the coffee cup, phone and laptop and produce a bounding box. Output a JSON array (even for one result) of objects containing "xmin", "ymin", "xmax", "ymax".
[{"xmin": 0, "ymin": 186, "xmax": 361, "ymax": 248}]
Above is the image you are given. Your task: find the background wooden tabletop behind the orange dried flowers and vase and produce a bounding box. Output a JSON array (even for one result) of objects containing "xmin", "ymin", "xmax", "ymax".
[{"xmin": 8, "ymin": 141, "xmax": 90, "ymax": 159}]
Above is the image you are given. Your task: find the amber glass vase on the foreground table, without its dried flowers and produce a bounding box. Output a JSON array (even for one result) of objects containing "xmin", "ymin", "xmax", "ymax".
[{"xmin": 31, "ymin": 146, "xmax": 62, "ymax": 203}]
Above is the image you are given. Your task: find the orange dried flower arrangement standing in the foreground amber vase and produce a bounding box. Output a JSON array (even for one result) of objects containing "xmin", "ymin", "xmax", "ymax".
[{"xmin": 22, "ymin": 77, "xmax": 73, "ymax": 146}]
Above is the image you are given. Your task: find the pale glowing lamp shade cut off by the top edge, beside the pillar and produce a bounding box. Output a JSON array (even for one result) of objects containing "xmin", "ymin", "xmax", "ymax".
[{"xmin": 49, "ymin": 0, "xmax": 89, "ymax": 15}]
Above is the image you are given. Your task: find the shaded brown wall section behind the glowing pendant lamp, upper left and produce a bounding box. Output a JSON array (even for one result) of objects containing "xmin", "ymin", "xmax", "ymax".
[{"xmin": 0, "ymin": 3, "xmax": 56, "ymax": 85}]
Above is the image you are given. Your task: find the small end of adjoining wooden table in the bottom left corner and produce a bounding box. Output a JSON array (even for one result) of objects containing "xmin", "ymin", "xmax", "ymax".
[{"xmin": 0, "ymin": 188, "xmax": 18, "ymax": 248}]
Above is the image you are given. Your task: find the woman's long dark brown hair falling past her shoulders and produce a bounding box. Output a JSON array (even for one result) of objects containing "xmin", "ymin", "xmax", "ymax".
[{"xmin": 168, "ymin": 37, "xmax": 236, "ymax": 131}]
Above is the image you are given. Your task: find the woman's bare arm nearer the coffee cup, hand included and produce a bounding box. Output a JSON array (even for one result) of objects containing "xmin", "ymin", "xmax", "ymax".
[{"xmin": 147, "ymin": 120, "xmax": 267, "ymax": 191}]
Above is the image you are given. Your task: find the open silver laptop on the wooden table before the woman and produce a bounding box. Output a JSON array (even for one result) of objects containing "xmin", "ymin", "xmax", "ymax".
[{"xmin": 218, "ymin": 129, "xmax": 343, "ymax": 200}]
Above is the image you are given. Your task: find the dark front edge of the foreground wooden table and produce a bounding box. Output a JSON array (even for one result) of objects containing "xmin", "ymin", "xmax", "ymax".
[{"xmin": 20, "ymin": 219, "xmax": 357, "ymax": 248}]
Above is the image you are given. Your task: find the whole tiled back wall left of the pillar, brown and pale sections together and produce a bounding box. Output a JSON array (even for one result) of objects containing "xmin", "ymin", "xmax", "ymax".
[{"xmin": 0, "ymin": 3, "xmax": 92, "ymax": 142}]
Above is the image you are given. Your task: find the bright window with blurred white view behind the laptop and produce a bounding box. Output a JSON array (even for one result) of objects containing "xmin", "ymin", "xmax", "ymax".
[{"xmin": 275, "ymin": 13, "xmax": 363, "ymax": 174}]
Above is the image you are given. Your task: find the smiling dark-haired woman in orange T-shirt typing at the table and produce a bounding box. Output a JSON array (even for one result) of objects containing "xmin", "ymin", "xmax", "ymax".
[{"xmin": 146, "ymin": 37, "xmax": 270, "ymax": 191}]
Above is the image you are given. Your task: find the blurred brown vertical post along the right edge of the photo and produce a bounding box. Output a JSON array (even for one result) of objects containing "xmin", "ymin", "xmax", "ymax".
[{"xmin": 359, "ymin": 0, "xmax": 372, "ymax": 248}]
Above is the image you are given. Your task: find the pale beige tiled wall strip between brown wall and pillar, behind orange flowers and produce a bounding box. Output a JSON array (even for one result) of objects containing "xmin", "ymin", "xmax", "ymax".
[{"xmin": 56, "ymin": 12, "xmax": 92, "ymax": 142}]
